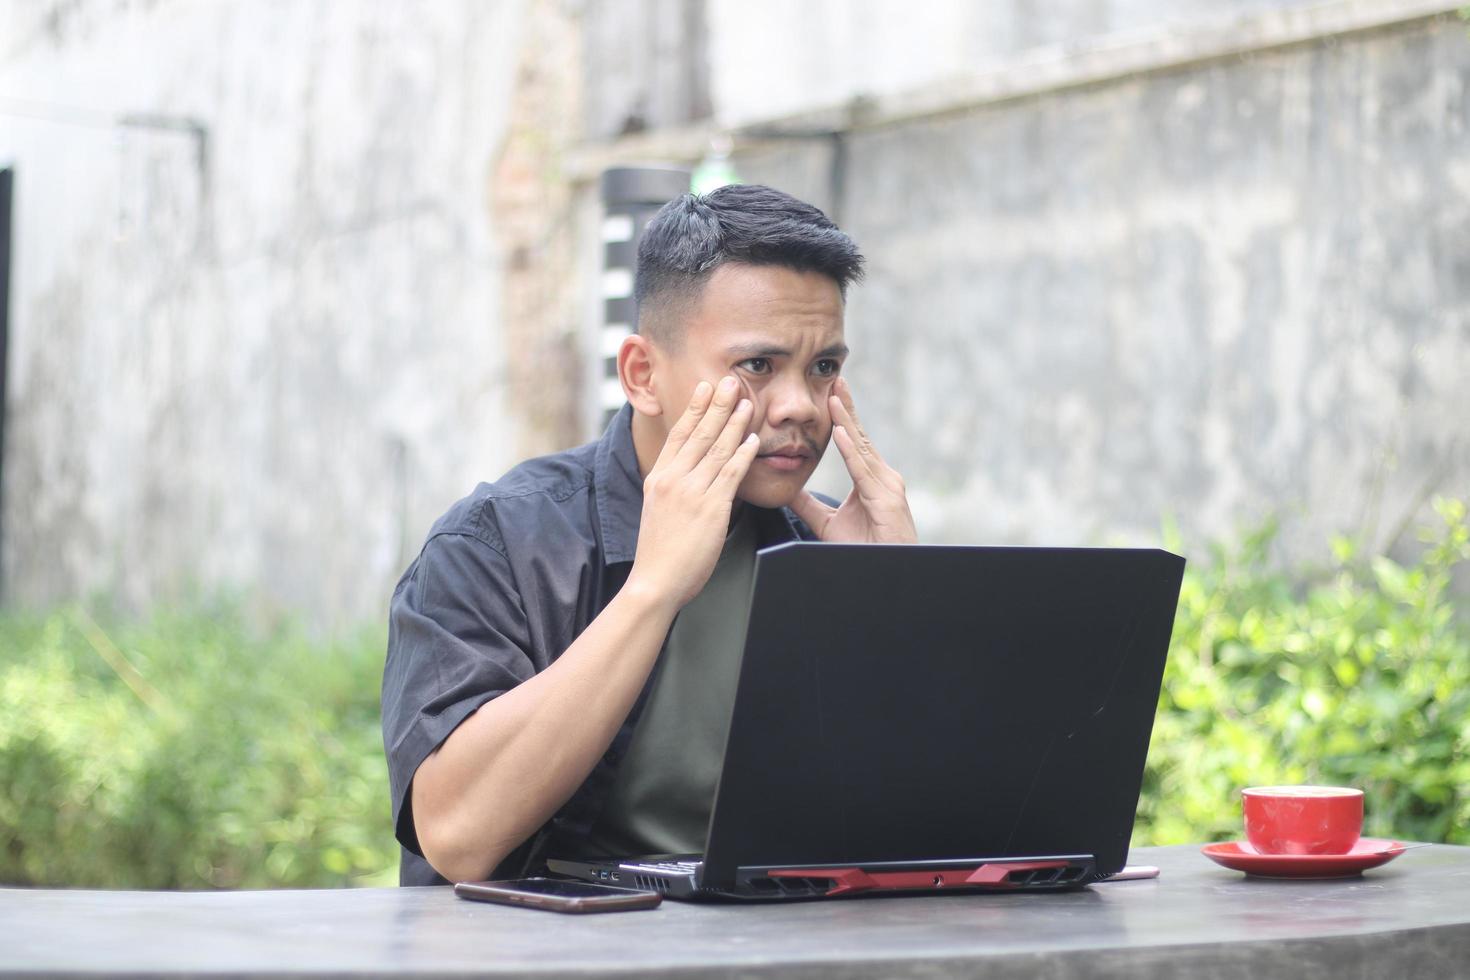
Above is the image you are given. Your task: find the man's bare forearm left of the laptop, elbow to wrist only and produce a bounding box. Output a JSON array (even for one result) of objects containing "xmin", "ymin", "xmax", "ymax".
[{"xmin": 413, "ymin": 580, "xmax": 676, "ymax": 880}]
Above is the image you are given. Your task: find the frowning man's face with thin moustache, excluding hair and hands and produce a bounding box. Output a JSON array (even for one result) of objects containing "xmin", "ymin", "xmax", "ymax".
[{"xmin": 659, "ymin": 263, "xmax": 847, "ymax": 507}]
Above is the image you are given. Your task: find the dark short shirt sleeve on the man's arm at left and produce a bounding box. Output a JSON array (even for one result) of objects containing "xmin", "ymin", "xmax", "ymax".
[{"xmin": 382, "ymin": 533, "xmax": 535, "ymax": 857}]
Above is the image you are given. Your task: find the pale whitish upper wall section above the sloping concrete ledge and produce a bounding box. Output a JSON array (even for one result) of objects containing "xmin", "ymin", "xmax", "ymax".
[{"xmin": 570, "ymin": 0, "xmax": 1314, "ymax": 132}]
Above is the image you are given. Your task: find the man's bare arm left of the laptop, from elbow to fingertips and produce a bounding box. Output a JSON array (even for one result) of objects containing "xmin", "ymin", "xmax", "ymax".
[{"xmin": 412, "ymin": 382, "xmax": 759, "ymax": 882}]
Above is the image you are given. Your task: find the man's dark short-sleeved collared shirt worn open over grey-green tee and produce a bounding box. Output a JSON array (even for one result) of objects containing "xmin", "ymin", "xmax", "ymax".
[{"xmin": 382, "ymin": 404, "xmax": 833, "ymax": 884}]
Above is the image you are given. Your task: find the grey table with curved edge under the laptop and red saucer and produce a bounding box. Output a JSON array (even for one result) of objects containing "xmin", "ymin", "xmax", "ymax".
[{"xmin": 0, "ymin": 845, "xmax": 1470, "ymax": 979}]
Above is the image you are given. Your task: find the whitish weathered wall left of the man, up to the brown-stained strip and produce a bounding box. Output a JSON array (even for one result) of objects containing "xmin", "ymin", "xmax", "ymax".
[{"xmin": 0, "ymin": 0, "xmax": 522, "ymax": 623}]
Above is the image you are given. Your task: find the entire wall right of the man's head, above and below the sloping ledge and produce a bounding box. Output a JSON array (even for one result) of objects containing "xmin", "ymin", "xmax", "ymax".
[{"xmin": 573, "ymin": 0, "xmax": 1470, "ymax": 567}]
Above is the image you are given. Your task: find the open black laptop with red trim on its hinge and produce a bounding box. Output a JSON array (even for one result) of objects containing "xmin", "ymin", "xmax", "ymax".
[{"xmin": 548, "ymin": 542, "xmax": 1185, "ymax": 901}]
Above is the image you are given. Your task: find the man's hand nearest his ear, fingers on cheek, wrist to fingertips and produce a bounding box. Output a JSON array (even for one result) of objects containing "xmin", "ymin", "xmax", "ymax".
[{"xmin": 628, "ymin": 378, "xmax": 760, "ymax": 611}]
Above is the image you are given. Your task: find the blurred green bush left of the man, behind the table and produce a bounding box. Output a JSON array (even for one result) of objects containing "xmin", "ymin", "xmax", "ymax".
[{"xmin": 0, "ymin": 604, "xmax": 397, "ymax": 889}]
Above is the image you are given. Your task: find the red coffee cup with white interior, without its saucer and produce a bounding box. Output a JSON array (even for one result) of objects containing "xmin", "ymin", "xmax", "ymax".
[{"xmin": 1241, "ymin": 786, "xmax": 1363, "ymax": 854}]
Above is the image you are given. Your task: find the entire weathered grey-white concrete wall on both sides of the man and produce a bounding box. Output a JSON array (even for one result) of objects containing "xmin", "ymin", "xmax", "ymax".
[{"xmin": 0, "ymin": 0, "xmax": 1470, "ymax": 624}]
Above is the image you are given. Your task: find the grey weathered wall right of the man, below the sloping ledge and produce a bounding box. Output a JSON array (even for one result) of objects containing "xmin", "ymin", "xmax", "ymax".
[{"xmin": 764, "ymin": 18, "xmax": 1470, "ymax": 564}]
